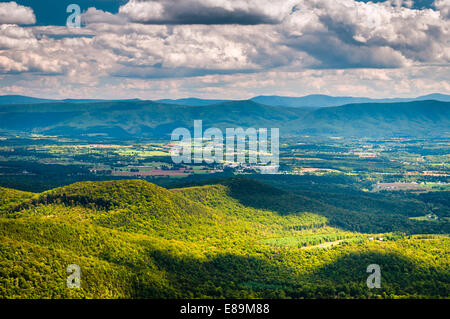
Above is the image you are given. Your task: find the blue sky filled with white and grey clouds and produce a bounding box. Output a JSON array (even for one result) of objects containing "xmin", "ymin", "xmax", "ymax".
[{"xmin": 0, "ymin": 0, "xmax": 450, "ymax": 99}]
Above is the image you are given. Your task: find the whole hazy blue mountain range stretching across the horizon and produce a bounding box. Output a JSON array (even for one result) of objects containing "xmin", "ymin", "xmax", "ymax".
[{"xmin": 0, "ymin": 100, "xmax": 450, "ymax": 139}]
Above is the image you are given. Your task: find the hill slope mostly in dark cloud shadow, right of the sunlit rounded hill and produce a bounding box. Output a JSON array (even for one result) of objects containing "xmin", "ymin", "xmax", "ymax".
[{"xmin": 172, "ymin": 178, "xmax": 450, "ymax": 234}]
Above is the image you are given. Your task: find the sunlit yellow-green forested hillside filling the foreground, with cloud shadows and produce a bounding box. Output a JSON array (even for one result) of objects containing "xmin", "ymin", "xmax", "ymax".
[{"xmin": 0, "ymin": 179, "xmax": 450, "ymax": 298}]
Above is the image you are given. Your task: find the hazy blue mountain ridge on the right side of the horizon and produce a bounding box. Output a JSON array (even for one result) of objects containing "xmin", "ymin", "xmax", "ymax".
[{"xmin": 296, "ymin": 101, "xmax": 450, "ymax": 137}]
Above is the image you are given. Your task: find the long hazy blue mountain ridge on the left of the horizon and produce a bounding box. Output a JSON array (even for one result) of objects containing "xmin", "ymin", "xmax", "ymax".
[{"xmin": 0, "ymin": 101, "xmax": 305, "ymax": 138}]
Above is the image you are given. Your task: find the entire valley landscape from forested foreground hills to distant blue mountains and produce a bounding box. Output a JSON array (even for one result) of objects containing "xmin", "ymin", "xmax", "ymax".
[{"xmin": 0, "ymin": 97, "xmax": 450, "ymax": 299}]
